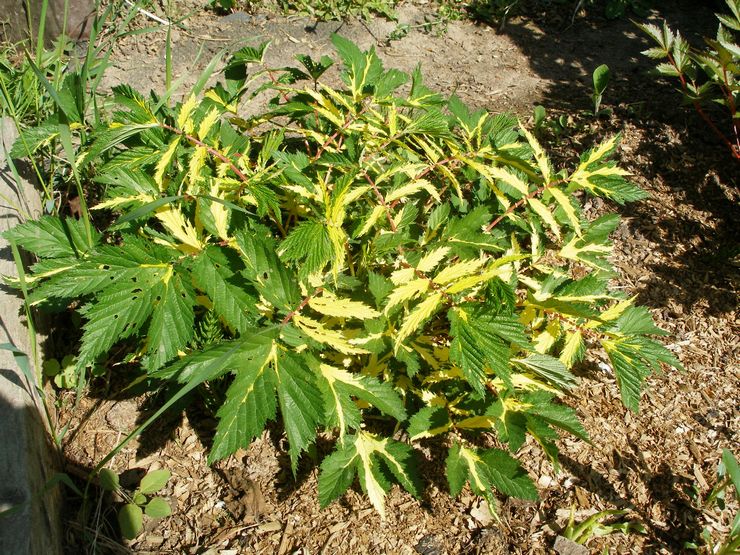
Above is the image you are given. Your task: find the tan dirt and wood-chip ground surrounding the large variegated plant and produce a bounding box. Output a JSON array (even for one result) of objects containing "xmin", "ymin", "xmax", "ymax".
[{"xmin": 49, "ymin": 2, "xmax": 740, "ymax": 555}]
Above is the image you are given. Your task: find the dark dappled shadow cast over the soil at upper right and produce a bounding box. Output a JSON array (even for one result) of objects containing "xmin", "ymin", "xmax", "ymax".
[{"xmin": 488, "ymin": 0, "xmax": 740, "ymax": 314}]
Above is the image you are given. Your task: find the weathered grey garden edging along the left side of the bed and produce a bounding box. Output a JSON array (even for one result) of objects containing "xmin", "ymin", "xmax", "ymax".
[{"xmin": 0, "ymin": 118, "xmax": 61, "ymax": 555}]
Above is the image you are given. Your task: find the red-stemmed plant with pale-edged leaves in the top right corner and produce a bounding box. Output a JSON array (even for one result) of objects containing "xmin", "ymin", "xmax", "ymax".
[{"xmin": 639, "ymin": 0, "xmax": 740, "ymax": 160}]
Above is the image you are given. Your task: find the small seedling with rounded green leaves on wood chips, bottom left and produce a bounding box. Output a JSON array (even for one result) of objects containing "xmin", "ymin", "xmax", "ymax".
[{"xmin": 98, "ymin": 468, "xmax": 172, "ymax": 540}]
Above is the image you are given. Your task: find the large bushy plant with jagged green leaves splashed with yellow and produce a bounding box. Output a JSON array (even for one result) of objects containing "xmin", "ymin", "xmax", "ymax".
[{"xmin": 2, "ymin": 36, "xmax": 679, "ymax": 515}]
